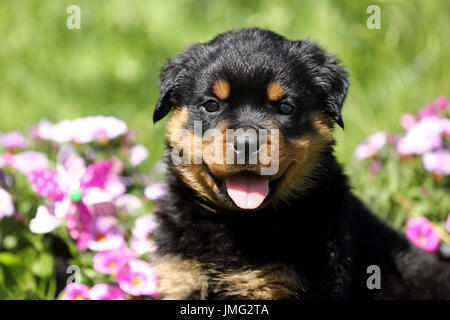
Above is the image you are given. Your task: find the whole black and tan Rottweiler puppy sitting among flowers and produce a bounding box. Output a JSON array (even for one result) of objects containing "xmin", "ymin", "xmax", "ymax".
[{"xmin": 154, "ymin": 29, "xmax": 450, "ymax": 299}]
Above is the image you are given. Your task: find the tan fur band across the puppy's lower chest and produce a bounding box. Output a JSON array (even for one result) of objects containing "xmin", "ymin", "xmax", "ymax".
[{"xmin": 156, "ymin": 255, "xmax": 306, "ymax": 300}]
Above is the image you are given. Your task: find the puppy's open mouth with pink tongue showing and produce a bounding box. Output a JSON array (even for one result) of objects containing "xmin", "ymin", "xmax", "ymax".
[{"xmin": 225, "ymin": 173, "xmax": 269, "ymax": 209}]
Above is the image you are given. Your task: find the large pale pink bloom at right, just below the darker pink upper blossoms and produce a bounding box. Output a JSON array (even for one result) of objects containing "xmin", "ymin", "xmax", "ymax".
[{"xmin": 397, "ymin": 118, "xmax": 450, "ymax": 155}]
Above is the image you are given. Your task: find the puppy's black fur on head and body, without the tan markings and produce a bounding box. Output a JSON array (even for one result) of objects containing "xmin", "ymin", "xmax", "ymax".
[{"xmin": 154, "ymin": 29, "xmax": 450, "ymax": 299}]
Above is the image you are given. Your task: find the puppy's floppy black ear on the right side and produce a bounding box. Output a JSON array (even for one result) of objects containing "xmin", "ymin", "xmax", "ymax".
[{"xmin": 301, "ymin": 40, "xmax": 349, "ymax": 129}]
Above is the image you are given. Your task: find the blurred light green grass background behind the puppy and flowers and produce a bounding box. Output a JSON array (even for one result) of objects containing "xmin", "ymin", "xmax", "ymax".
[{"xmin": 0, "ymin": 0, "xmax": 450, "ymax": 165}]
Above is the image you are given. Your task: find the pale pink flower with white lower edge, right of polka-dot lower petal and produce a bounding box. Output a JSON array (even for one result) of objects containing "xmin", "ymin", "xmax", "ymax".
[{"xmin": 87, "ymin": 216, "xmax": 125, "ymax": 251}]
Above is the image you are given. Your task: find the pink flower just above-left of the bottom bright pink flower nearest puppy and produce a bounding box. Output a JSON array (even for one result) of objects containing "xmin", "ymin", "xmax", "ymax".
[{"xmin": 94, "ymin": 248, "xmax": 132, "ymax": 274}]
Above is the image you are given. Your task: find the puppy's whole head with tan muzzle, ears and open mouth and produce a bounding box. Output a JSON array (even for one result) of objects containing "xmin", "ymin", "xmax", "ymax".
[{"xmin": 154, "ymin": 29, "xmax": 348, "ymax": 210}]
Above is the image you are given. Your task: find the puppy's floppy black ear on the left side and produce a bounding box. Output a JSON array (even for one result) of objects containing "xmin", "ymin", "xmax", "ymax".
[{"xmin": 153, "ymin": 52, "xmax": 188, "ymax": 123}]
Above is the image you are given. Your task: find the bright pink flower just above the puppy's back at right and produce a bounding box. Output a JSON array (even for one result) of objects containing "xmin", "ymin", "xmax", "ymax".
[{"xmin": 406, "ymin": 217, "xmax": 440, "ymax": 252}]
